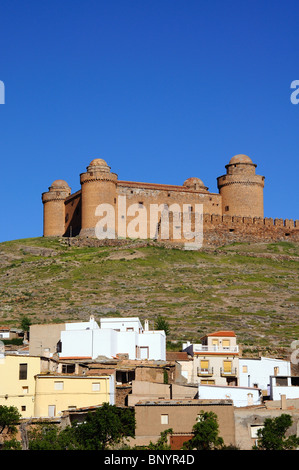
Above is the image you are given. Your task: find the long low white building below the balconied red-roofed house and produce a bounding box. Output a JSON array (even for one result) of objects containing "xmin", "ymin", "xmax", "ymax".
[{"xmin": 198, "ymin": 384, "xmax": 261, "ymax": 407}]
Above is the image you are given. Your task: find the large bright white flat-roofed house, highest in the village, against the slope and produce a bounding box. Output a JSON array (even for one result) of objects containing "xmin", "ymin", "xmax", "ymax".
[{"xmin": 59, "ymin": 316, "xmax": 166, "ymax": 361}]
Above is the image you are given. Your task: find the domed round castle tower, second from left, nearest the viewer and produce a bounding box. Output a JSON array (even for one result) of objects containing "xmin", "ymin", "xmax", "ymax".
[{"xmin": 80, "ymin": 158, "xmax": 117, "ymax": 237}]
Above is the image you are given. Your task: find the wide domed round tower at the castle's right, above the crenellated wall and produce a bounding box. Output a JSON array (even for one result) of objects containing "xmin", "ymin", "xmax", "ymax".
[{"xmin": 217, "ymin": 155, "xmax": 265, "ymax": 218}]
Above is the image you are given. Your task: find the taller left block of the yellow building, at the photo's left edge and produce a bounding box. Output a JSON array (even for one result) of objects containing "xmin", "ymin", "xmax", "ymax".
[{"xmin": 0, "ymin": 354, "xmax": 42, "ymax": 418}]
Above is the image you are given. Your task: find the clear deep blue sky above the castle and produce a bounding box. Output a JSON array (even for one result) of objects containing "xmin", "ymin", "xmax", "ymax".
[{"xmin": 0, "ymin": 0, "xmax": 299, "ymax": 241}]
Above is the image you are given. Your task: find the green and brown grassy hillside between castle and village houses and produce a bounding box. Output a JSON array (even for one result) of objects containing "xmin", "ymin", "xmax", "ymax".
[{"xmin": 0, "ymin": 238, "xmax": 299, "ymax": 356}]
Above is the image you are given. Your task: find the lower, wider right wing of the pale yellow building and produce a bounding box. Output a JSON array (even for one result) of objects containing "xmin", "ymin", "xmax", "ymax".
[{"xmin": 34, "ymin": 374, "xmax": 114, "ymax": 417}]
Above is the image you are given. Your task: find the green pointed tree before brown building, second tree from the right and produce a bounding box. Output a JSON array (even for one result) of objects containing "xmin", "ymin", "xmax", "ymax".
[{"xmin": 183, "ymin": 411, "xmax": 223, "ymax": 450}]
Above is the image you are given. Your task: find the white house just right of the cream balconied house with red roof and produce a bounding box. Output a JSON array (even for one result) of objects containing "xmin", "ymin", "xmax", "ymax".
[{"xmin": 239, "ymin": 357, "xmax": 291, "ymax": 393}]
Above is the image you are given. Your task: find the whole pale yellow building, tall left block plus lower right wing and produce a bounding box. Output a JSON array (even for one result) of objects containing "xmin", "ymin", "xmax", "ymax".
[{"xmin": 0, "ymin": 354, "xmax": 115, "ymax": 418}]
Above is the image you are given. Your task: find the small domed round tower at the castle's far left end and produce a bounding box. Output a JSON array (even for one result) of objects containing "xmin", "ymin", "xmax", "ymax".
[{"xmin": 42, "ymin": 180, "xmax": 71, "ymax": 237}]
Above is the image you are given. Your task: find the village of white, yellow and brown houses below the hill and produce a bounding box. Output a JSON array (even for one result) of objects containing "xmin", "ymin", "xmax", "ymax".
[{"xmin": 0, "ymin": 306, "xmax": 299, "ymax": 450}]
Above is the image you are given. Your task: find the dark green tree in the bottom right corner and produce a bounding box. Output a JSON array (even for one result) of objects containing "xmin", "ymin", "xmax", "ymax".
[{"xmin": 253, "ymin": 413, "xmax": 299, "ymax": 450}]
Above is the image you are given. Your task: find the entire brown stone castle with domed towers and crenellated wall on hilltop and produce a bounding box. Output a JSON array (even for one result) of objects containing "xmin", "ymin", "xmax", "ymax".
[{"xmin": 42, "ymin": 155, "xmax": 299, "ymax": 250}]
